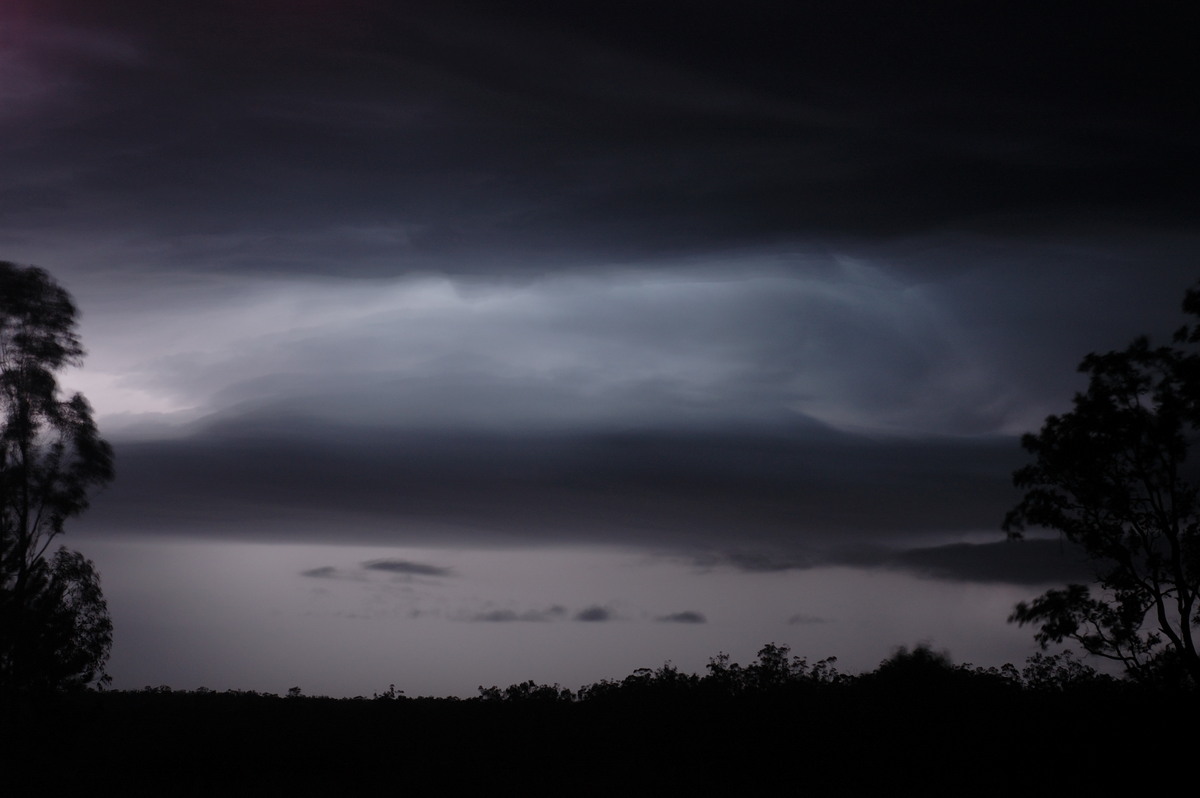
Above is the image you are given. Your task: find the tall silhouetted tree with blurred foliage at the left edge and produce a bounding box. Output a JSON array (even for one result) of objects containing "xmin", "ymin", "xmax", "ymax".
[{"xmin": 0, "ymin": 262, "xmax": 113, "ymax": 691}]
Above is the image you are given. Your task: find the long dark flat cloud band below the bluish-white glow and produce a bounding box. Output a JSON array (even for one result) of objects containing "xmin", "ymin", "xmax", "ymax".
[{"xmin": 84, "ymin": 420, "xmax": 1022, "ymax": 556}]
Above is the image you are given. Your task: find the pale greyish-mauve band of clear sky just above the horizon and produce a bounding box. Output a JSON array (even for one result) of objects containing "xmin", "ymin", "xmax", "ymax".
[{"xmin": 78, "ymin": 539, "xmax": 1051, "ymax": 696}]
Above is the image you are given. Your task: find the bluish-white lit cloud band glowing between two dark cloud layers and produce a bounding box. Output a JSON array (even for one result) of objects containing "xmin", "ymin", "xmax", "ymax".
[{"xmin": 64, "ymin": 259, "xmax": 1007, "ymax": 434}]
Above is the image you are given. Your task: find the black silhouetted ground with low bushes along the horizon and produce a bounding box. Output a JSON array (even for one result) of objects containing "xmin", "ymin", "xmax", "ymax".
[{"xmin": 0, "ymin": 652, "xmax": 1200, "ymax": 797}]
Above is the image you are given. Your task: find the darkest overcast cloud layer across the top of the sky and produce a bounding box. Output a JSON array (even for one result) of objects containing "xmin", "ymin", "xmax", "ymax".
[{"xmin": 2, "ymin": 0, "xmax": 1198, "ymax": 266}]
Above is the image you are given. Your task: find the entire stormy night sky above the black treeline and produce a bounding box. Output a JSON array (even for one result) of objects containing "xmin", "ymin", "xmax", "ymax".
[{"xmin": 0, "ymin": 0, "xmax": 1200, "ymax": 696}]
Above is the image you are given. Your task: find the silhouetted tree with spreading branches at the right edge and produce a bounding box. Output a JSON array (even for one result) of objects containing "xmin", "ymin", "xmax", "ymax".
[{"xmin": 1004, "ymin": 286, "xmax": 1200, "ymax": 684}]
